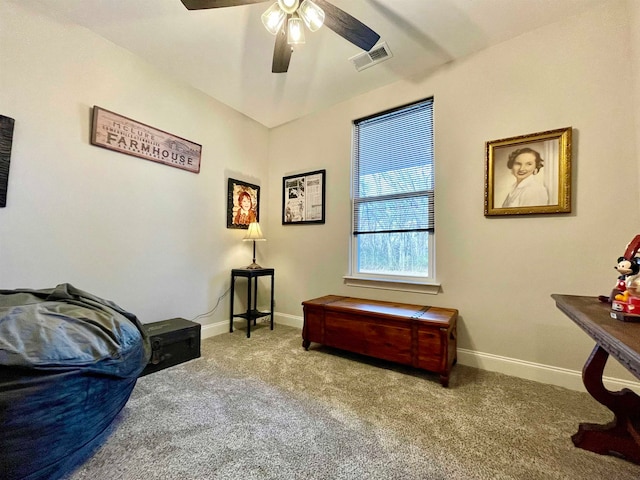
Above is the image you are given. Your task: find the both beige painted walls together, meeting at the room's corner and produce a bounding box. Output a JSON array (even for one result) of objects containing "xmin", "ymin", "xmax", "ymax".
[{"xmin": 0, "ymin": 0, "xmax": 640, "ymax": 387}]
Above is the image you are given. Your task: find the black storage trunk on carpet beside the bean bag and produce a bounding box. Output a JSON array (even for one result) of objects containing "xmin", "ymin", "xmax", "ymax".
[{"xmin": 140, "ymin": 318, "xmax": 201, "ymax": 377}]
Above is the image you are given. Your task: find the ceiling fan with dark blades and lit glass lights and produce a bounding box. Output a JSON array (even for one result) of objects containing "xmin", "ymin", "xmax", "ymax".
[{"xmin": 181, "ymin": 0, "xmax": 380, "ymax": 73}]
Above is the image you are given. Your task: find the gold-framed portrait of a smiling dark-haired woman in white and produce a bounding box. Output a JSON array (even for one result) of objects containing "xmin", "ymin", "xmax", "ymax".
[{"xmin": 484, "ymin": 127, "xmax": 571, "ymax": 216}]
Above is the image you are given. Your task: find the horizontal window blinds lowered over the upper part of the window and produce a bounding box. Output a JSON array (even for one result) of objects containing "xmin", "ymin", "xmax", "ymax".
[{"xmin": 353, "ymin": 99, "xmax": 435, "ymax": 235}]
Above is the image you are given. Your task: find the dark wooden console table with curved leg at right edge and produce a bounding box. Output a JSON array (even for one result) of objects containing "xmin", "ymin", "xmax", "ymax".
[{"xmin": 551, "ymin": 294, "xmax": 640, "ymax": 464}]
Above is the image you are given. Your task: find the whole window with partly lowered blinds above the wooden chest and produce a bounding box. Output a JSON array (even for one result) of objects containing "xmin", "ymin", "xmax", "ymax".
[{"xmin": 349, "ymin": 99, "xmax": 435, "ymax": 290}]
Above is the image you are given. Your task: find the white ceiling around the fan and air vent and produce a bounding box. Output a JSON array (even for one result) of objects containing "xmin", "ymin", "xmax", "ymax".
[{"xmin": 16, "ymin": 0, "xmax": 603, "ymax": 127}]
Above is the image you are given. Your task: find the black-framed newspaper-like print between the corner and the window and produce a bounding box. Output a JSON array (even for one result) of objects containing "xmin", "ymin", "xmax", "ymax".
[{"xmin": 282, "ymin": 170, "xmax": 327, "ymax": 225}]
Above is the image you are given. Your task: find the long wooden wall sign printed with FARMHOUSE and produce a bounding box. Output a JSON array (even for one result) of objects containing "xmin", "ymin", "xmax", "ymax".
[{"xmin": 91, "ymin": 106, "xmax": 202, "ymax": 173}]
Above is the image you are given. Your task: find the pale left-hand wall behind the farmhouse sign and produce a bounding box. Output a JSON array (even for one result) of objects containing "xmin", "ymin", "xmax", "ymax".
[{"xmin": 0, "ymin": 2, "xmax": 269, "ymax": 324}]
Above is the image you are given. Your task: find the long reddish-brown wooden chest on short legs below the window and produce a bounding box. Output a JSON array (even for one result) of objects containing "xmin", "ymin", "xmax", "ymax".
[{"xmin": 302, "ymin": 295, "xmax": 458, "ymax": 387}]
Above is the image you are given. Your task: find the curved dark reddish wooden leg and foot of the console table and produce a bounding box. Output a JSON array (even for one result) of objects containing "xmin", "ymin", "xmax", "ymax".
[{"xmin": 571, "ymin": 345, "xmax": 640, "ymax": 464}]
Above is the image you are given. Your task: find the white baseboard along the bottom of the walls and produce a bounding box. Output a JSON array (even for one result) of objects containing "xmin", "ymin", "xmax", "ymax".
[{"xmin": 202, "ymin": 312, "xmax": 640, "ymax": 392}]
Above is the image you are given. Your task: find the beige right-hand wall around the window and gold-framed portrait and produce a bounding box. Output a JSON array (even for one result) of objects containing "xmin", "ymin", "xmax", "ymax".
[{"xmin": 269, "ymin": 2, "xmax": 640, "ymax": 385}]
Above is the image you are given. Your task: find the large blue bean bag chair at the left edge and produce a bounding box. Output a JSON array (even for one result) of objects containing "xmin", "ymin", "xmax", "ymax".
[{"xmin": 0, "ymin": 284, "xmax": 150, "ymax": 480}]
